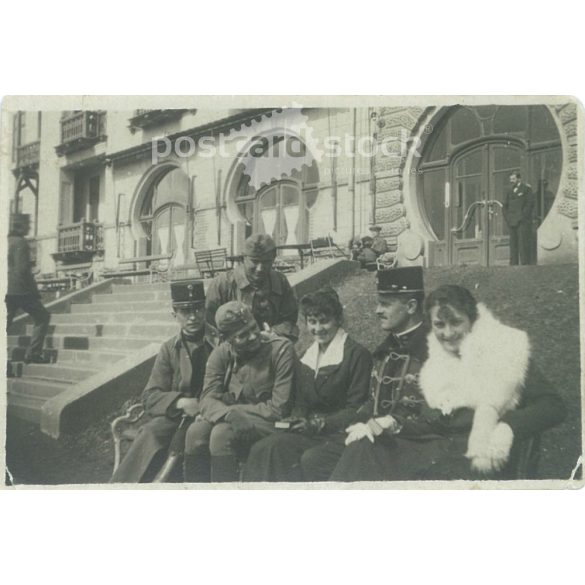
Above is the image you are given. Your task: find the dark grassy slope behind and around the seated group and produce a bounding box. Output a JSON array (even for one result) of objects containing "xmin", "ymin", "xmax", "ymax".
[{"xmin": 8, "ymin": 265, "xmax": 581, "ymax": 484}]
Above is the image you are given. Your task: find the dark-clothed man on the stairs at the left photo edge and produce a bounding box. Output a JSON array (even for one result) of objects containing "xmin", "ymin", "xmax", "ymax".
[{"xmin": 6, "ymin": 213, "xmax": 51, "ymax": 364}]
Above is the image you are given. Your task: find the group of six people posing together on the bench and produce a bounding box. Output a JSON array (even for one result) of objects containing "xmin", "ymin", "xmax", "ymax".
[{"xmin": 112, "ymin": 235, "xmax": 565, "ymax": 483}]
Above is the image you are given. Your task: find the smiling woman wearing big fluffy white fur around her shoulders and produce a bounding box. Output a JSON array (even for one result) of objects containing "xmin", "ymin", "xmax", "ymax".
[{"xmin": 331, "ymin": 285, "xmax": 565, "ymax": 481}]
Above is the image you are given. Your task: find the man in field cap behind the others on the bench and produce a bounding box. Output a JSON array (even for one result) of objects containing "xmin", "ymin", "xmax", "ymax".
[{"xmin": 205, "ymin": 234, "xmax": 299, "ymax": 341}]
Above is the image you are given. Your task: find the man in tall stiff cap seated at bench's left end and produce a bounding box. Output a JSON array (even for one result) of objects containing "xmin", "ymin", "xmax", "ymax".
[{"xmin": 112, "ymin": 280, "xmax": 211, "ymax": 483}]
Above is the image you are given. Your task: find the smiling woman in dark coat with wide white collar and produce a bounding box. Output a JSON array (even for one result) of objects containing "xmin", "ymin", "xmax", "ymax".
[{"xmin": 244, "ymin": 288, "xmax": 372, "ymax": 481}]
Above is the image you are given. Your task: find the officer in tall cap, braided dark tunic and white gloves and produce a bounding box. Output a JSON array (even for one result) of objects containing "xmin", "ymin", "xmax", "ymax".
[{"xmin": 327, "ymin": 266, "xmax": 428, "ymax": 481}]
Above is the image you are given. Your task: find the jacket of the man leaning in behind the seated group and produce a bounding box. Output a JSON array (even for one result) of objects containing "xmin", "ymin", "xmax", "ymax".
[{"xmin": 205, "ymin": 265, "xmax": 299, "ymax": 339}]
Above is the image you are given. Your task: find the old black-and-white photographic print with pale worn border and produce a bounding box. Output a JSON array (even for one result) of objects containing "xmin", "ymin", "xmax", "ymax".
[{"xmin": 0, "ymin": 96, "xmax": 584, "ymax": 489}]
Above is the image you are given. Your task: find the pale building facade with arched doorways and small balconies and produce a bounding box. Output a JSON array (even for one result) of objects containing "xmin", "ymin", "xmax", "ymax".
[{"xmin": 3, "ymin": 103, "xmax": 582, "ymax": 275}]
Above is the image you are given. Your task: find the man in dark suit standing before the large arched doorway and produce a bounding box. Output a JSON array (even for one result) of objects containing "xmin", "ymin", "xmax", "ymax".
[{"xmin": 502, "ymin": 172, "xmax": 534, "ymax": 266}]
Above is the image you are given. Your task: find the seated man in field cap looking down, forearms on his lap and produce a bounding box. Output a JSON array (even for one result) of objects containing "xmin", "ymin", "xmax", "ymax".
[{"xmin": 186, "ymin": 301, "xmax": 298, "ymax": 482}]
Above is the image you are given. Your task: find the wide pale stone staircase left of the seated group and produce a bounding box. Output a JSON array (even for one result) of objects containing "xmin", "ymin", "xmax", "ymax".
[{"xmin": 7, "ymin": 283, "xmax": 177, "ymax": 423}]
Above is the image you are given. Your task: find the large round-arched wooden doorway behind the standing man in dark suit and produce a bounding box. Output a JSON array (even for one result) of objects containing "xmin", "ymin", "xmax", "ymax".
[{"xmin": 418, "ymin": 106, "xmax": 562, "ymax": 266}]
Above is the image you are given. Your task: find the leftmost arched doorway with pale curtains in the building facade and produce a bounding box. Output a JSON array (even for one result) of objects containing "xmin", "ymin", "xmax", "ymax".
[{"xmin": 138, "ymin": 168, "xmax": 190, "ymax": 266}]
